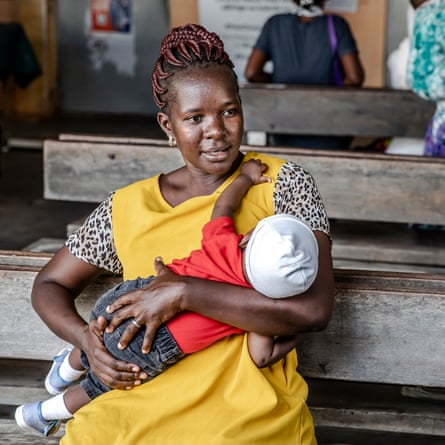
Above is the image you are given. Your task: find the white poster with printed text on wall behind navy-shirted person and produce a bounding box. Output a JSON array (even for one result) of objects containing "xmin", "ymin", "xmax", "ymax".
[{"xmin": 198, "ymin": 0, "xmax": 358, "ymax": 82}]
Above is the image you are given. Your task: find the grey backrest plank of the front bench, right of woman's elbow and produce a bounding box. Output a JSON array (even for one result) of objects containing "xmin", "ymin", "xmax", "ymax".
[{"xmin": 297, "ymin": 270, "xmax": 445, "ymax": 387}]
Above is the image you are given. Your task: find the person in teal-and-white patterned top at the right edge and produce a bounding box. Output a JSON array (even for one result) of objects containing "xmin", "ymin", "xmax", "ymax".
[{"xmin": 407, "ymin": 0, "xmax": 445, "ymax": 157}]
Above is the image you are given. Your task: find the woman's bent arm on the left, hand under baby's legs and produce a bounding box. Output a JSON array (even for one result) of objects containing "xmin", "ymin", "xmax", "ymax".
[{"xmin": 31, "ymin": 247, "xmax": 149, "ymax": 389}]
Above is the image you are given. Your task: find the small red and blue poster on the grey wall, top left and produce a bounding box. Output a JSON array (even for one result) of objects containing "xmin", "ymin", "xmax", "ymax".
[{"xmin": 91, "ymin": 0, "xmax": 131, "ymax": 33}]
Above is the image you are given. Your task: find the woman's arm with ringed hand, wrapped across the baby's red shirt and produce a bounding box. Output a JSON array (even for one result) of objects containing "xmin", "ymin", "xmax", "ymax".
[{"xmin": 107, "ymin": 231, "xmax": 334, "ymax": 350}]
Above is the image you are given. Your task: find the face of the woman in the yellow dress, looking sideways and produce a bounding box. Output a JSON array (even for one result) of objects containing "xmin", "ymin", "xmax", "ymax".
[{"xmin": 158, "ymin": 65, "xmax": 244, "ymax": 175}]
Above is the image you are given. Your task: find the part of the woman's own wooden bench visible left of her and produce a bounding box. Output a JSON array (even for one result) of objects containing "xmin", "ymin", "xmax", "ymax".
[{"xmin": 0, "ymin": 251, "xmax": 117, "ymax": 445}]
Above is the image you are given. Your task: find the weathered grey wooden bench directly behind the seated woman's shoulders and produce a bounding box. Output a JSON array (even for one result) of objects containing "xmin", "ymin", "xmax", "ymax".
[{"xmin": 44, "ymin": 135, "xmax": 445, "ymax": 273}]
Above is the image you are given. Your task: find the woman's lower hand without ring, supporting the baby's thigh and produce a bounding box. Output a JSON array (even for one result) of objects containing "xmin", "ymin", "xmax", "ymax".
[{"xmin": 84, "ymin": 317, "xmax": 147, "ymax": 390}]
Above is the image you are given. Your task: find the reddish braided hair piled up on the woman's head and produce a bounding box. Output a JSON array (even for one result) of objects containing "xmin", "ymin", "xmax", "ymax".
[{"xmin": 151, "ymin": 24, "xmax": 236, "ymax": 110}]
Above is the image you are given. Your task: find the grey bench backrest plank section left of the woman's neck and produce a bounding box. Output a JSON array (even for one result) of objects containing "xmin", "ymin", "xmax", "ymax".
[{"xmin": 43, "ymin": 140, "xmax": 183, "ymax": 202}]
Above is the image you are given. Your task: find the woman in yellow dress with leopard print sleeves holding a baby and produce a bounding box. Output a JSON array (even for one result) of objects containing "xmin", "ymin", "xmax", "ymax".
[{"xmin": 32, "ymin": 25, "xmax": 333, "ymax": 445}]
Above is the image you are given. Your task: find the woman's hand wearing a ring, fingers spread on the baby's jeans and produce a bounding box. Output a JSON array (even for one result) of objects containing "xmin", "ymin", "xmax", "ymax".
[{"xmin": 106, "ymin": 257, "xmax": 186, "ymax": 354}]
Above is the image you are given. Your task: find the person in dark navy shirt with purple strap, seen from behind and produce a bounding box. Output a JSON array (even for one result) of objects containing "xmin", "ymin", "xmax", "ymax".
[{"xmin": 244, "ymin": 0, "xmax": 365, "ymax": 149}]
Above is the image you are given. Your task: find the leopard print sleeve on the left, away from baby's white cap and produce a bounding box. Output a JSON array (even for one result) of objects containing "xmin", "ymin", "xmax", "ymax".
[{"xmin": 65, "ymin": 193, "xmax": 122, "ymax": 274}]
